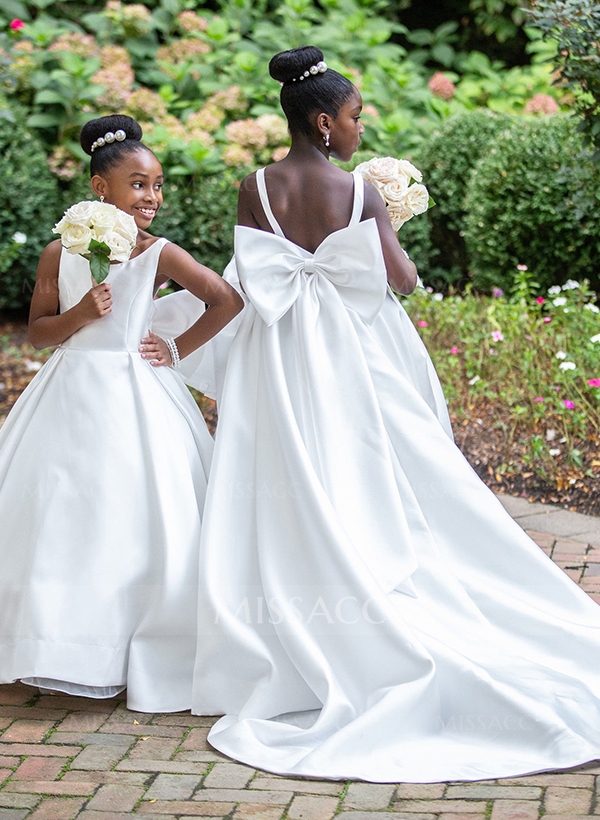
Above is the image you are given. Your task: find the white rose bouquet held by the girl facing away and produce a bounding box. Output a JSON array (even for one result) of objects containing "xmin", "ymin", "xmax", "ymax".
[{"xmin": 355, "ymin": 157, "xmax": 435, "ymax": 231}]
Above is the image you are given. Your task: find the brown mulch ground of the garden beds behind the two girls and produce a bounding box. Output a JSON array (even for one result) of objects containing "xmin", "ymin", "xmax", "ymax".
[{"xmin": 0, "ymin": 316, "xmax": 600, "ymax": 515}]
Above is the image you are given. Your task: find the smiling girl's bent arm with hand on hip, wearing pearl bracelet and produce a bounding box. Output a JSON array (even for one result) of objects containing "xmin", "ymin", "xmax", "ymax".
[{"xmin": 140, "ymin": 242, "xmax": 244, "ymax": 365}]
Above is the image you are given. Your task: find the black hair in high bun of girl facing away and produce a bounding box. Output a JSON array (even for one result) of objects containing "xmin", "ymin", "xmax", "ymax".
[{"xmin": 269, "ymin": 46, "xmax": 356, "ymax": 136}]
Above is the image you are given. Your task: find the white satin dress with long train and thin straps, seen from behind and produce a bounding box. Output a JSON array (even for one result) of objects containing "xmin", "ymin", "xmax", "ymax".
[{"xmin": 192, "ymin": 168, "xmax": 600, "ymax": 782}]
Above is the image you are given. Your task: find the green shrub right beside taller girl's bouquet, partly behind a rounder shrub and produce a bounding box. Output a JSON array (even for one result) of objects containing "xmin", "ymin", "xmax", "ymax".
[{"xmin": 414, "ymin": 109, "xmax": 511, "ymax": 284}]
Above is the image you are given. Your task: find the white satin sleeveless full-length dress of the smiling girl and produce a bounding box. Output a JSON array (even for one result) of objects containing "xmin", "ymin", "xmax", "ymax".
[{"xmin": 0, "ymin": 239, "xmax": 213, "ymax": 711}]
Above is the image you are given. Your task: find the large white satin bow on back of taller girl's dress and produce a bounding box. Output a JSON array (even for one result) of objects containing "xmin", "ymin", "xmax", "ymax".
[{"xmin": 235, "ymin": 219, "xmax": 387, "ymax": 325}]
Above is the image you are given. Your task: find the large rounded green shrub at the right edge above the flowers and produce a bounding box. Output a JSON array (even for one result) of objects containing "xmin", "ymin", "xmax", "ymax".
[{"xmin": 465, "ymin": 115, "xmax": 600, "ymax": 289}]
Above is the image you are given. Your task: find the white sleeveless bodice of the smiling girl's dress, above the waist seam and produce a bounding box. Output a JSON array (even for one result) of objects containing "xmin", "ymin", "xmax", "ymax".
[{"xmin": 58, "ymin": 238, "xmax": 168, "ymax": 351}]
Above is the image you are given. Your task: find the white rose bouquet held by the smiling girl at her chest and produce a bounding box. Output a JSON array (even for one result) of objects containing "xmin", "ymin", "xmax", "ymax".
[{"xmin": 52, "ymin": 201, "xmax": 137, "ymax": 284}]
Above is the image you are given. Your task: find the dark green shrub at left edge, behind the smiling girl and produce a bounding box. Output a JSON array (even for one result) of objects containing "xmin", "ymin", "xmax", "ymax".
[{"xmin": 0, "ymin": 100, "xmax": 61, "ymax": 309}]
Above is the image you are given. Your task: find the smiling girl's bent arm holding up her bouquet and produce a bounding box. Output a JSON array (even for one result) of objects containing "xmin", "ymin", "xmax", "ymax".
[{"xmin": 29, "ymin": 239, "xmax": 112, "ymax": 350}]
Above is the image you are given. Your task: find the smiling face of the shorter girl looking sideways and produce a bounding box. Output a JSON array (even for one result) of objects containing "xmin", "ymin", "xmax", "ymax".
[{"xmin": 91, "ymin": 149, "xmax": 164, "ymax": 231}]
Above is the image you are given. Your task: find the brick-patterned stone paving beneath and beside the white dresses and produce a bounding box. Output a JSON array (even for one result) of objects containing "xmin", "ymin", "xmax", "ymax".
[{"xmin": 0, "ymin": 498, "xmax": 600, "ymax": 820}]
